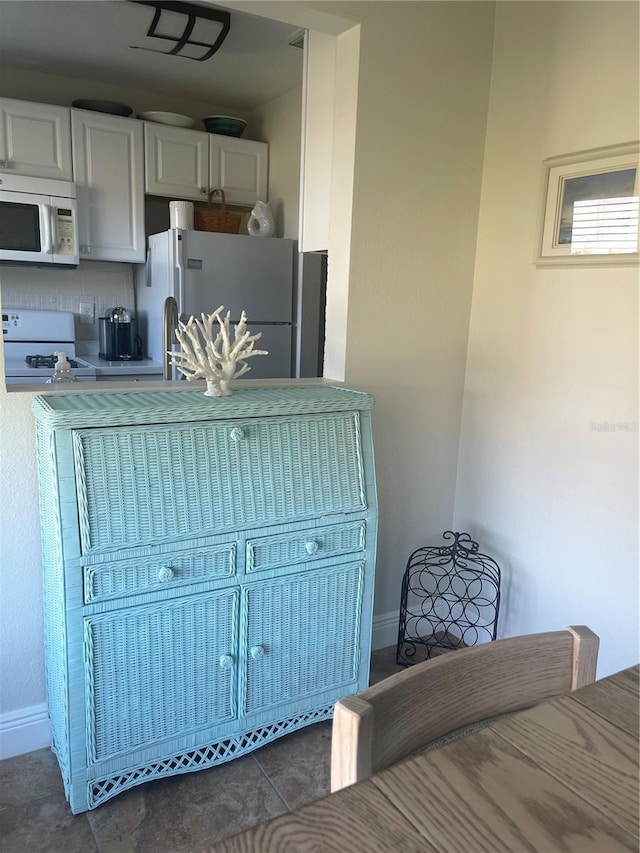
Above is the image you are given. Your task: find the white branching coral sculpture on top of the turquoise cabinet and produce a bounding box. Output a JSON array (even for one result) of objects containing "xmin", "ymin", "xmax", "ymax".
[{"xmin": 169, "ymin": 305, "xmax": 269, "ymax": 397}]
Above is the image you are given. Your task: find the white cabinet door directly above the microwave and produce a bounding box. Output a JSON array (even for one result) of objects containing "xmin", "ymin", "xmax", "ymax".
[{"xmin": 0, "ymin": 98, "xmax": 73, "ymax": 181}]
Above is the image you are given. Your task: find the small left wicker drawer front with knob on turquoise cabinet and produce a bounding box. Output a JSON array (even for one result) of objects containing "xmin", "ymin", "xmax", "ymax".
[{"xmin": 84, "ymin": 542, "xmax": 236, "ymax": 604}]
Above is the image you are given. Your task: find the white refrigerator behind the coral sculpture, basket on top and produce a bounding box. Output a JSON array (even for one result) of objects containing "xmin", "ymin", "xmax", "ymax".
[{"xmin": 136, "ymin": 229, "xmax": 295, "ymax": 379}]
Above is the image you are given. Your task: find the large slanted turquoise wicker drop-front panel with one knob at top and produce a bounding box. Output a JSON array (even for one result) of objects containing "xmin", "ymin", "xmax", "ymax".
[{"xmin": 73, "ymin": 412, "xmax": 366, "ymax": 553}]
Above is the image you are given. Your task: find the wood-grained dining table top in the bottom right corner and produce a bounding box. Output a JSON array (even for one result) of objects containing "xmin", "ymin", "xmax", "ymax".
[{"xmin": 211, "ymin": 666, "xmax": 640, "ymax": 853}]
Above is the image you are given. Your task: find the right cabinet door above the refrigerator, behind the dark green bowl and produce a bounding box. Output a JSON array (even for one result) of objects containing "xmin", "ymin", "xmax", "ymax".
[{"xmin": 209, "ymin": 138, "xmax": 269, "ymax": 204}]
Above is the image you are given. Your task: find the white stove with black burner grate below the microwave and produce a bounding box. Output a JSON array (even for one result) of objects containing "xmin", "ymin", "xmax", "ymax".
[{"xmin": 2, "ymin": 308, "xmax": 96, "ymax": 385}]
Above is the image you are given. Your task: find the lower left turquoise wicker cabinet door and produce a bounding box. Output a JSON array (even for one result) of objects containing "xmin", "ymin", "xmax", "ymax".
[{"xmin": 84, "ymin": 588, "xmax": 239, "ymax": 762}]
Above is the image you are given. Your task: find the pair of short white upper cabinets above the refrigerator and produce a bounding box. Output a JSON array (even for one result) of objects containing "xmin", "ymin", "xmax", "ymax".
[{"xmin": 144, "ymin": 122, "xmax": 269, "ymax": 204}]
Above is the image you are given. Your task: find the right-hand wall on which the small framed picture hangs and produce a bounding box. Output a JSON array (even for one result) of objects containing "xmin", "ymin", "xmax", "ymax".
[{"xmin": 455, "ymin": 2, "xmax": 639, "ymax": 676}]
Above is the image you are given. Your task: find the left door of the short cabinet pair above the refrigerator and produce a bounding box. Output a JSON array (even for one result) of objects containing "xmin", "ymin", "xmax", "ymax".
[{"xmin": 144, "ymin": 122, "xmax": 209, "ymax": 199}]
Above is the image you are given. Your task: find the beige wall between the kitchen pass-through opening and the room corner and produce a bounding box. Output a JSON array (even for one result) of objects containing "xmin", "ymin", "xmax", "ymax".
[{"xmin": 329, "ymin": 2, "xmax": 494, "ymax": 615}]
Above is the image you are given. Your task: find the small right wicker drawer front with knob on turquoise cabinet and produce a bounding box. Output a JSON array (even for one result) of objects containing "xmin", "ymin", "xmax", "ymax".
[{"xmin": 247, "ymin": 521, "xmax": 365, "ymax": 572}]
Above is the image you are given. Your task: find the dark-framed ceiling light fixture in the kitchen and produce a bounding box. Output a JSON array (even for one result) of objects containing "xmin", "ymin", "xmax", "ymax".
[{"xmin": 129, "ymin": 0, "xmax": 231, "ymax": 62}]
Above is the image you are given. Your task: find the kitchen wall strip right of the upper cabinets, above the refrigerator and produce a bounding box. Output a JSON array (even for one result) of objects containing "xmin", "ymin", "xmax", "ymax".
[{"xmin": 249, "ymin": 86, "xmax": 302, "ymax": 240}]
